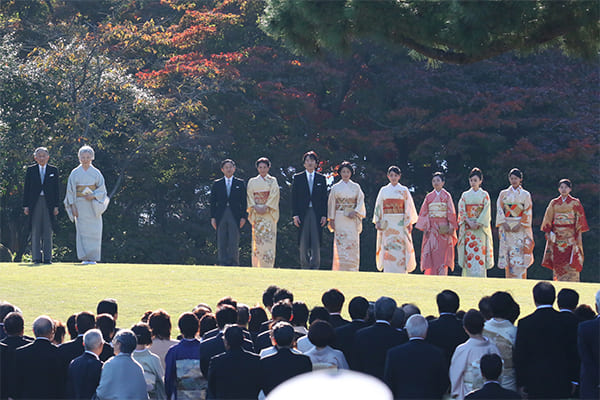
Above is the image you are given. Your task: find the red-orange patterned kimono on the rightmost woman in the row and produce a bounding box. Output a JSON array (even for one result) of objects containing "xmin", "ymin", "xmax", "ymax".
[{"xmin": 542, "ymin": 195, "xmax": 590, "ymax": 282}]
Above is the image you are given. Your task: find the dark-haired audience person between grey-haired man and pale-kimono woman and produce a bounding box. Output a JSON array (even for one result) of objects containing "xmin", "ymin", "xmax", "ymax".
[{"xmin": 425, "ymin": 290, "xmax": 469, "ymax": 366}]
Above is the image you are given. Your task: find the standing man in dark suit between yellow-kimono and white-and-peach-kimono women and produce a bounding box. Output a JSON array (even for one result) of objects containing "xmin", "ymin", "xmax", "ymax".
[{"xmin": 292, "ymin": 151, "xmax": 327, "ymax": 269}]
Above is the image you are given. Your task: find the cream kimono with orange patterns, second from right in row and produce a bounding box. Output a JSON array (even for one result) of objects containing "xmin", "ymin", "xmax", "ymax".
[{"xmin": 496, "ymin": 186, "xmax": 534, "ymax": 279}]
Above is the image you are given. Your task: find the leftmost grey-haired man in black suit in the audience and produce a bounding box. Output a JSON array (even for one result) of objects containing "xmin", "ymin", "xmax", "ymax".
[{"xmin": 14, "ymin": 315, "xmax": 65, "ymax": 399}]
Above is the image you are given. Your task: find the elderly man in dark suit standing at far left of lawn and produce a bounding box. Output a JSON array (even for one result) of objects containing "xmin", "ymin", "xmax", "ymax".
[{"xmin": 23, "ymin": 147, "xmax": 60, "ymax": 264}]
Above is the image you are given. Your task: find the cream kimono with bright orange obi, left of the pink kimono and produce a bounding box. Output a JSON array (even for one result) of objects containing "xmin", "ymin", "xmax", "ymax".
[{"xmin": 373, "ymin": 183, "xmax": 418, "ymax": 273}]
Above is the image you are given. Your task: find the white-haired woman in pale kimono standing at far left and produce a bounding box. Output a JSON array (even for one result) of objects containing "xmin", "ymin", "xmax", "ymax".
[{"xmin": 64, "ymin": 146, "xmax": 109, "ymax": 264}]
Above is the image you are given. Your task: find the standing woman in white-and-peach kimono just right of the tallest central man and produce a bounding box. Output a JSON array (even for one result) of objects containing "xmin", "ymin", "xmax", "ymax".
[{"xmin": 327, "ymin": 161, "xmax": 366, "ymax": 271}]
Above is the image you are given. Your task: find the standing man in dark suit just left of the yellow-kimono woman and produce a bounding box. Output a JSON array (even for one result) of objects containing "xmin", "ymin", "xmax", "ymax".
[{"xmin": 210, "ymin": 159, "xmax": 248, "ymax": 265}]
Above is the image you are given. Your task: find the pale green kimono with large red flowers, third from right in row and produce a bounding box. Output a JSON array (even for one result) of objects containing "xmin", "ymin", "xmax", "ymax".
[{"xmin": 457, "ymin": 189, "xmax": 494, "ymax": 278}]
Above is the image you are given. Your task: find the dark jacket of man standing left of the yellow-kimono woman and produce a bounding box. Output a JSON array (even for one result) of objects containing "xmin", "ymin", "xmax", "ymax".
[{"xmin": 210, "ymin": 176, "xmax": 248, "ymax": 226}]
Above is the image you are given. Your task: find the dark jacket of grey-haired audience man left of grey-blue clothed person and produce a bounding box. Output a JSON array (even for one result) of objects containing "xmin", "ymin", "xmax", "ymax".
[{"xmin": 66, "ymin": 353, "xmax": 102, "ymax": 399}]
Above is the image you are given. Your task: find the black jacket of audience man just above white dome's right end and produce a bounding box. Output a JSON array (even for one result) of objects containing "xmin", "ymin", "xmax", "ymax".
[{"xmin": 354, "ymin": 322, "xmax": 408, "ymax": 380}]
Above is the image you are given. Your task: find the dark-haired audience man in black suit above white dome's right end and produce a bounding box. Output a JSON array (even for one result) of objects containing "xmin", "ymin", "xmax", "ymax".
[{"xmin": 354, "ymin": 297, "xmax": 408, "ymax": 380}]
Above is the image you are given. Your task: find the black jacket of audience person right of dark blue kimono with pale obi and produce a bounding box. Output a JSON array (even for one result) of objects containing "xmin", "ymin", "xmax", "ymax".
[{"xmin": 207, "ymin": 349, "xmax": 260, "ymax": 400}]
